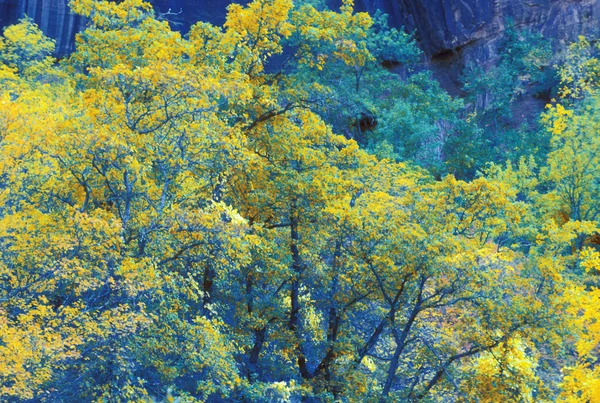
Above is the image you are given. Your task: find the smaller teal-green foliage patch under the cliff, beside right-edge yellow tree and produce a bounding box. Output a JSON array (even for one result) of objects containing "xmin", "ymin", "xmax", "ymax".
[{"xmin": 462, "ymin": 24, "xmax": 557, "ymax": 167}]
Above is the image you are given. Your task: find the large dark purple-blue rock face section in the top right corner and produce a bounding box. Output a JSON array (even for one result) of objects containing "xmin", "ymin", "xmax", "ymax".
[{"xmin": 346, "ymin": 0, "xmax": 600, "ymax": 94}]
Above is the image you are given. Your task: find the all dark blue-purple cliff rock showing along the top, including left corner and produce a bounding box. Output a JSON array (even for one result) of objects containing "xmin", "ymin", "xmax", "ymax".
[{"xmin": 0, "ymin": 0, "xmax": 600, "ymax": 87}]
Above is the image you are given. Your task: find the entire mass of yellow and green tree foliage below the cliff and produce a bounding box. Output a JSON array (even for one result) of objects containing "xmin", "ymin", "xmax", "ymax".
[{"xmin": 0, "ymin": 0, "xmax": 600, "ymax": 403}]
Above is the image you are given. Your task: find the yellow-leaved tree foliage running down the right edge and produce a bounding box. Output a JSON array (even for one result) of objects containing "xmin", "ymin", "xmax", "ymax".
[{"xmin": 489, "ymin": 37, "xmax": 600, "ymax": 402}]
